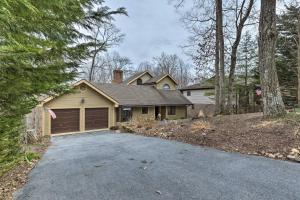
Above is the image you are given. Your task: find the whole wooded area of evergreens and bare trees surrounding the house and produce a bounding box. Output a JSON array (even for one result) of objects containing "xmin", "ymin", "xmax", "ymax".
[{"xmin": 0, "ymin": 0, "xmax": 300, "ymax": 180}]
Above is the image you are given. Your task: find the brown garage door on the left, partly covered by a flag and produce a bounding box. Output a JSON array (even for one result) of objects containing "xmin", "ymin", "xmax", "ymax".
[{"xmin": 51, "ymin": 109, "xmax": 80, "ymax": 134}]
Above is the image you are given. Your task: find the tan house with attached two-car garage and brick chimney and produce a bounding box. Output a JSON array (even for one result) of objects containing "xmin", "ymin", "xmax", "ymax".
[{"xmin": 29, "ymin": 70, "xmax": 192, "ymax": 135}]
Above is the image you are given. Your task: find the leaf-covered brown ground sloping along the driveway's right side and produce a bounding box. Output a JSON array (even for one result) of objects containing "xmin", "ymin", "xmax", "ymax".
[{"xmin": 123, "ymin": 113, "xmax": 300, "ymax": 161}]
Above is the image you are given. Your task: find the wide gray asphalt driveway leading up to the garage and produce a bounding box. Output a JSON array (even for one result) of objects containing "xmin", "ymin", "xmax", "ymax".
[{"xmin": 15, "ymin": 132, "xmax": 300, "ymax": 200}]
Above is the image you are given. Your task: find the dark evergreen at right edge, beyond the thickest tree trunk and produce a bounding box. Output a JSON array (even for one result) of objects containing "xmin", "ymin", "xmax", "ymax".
[{"xmin": 276, "ymin": 5, "xmax": 300, "ymax": 104}]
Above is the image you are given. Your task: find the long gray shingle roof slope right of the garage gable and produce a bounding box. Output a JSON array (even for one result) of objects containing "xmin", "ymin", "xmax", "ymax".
[{"xmin": 95, "ymin": 84, "xmax": 192, "ymax": 106}]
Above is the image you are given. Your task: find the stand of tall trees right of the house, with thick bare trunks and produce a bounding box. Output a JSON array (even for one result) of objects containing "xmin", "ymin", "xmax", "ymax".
[{"xmin": 175, "ymin": 0, "xmax": 300, "ymax": 116}]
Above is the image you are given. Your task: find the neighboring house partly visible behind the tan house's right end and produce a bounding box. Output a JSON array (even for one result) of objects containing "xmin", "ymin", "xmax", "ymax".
[{"xmin": 180, "ymin": 81, "xmax": 215, "ymax": 118}]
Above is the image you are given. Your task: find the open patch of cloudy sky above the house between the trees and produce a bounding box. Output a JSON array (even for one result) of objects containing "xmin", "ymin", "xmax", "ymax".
[{"xmin": 106, "ymin": 0, "xmax": 190, "ymax": 67}]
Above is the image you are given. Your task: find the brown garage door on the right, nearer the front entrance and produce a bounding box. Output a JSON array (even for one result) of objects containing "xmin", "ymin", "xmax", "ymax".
[{"xmin": 85, "ymin": 108, "xmax": 108, "ymax": 130}]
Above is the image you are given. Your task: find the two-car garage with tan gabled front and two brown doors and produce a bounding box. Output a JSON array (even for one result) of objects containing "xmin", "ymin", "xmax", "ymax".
[{"xmin": 42, "ymin": 82, "xmax": 117, "ymax": 135}]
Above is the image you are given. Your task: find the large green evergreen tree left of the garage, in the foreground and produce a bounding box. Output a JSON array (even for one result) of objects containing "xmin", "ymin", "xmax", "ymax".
[{"xmin": 0, "ymin": 0, "xmax": 125, "ymax": 169}]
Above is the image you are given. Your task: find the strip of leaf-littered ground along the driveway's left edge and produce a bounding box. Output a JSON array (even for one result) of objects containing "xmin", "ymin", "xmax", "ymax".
[{"xmin": 0, "ymin": 138, "xmax": 50, "ymax": 200}]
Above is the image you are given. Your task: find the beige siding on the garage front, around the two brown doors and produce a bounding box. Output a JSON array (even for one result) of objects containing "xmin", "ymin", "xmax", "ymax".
[{"xmin": 43, "ymin": 83, "xmax": 116, "ymax": 135}]
